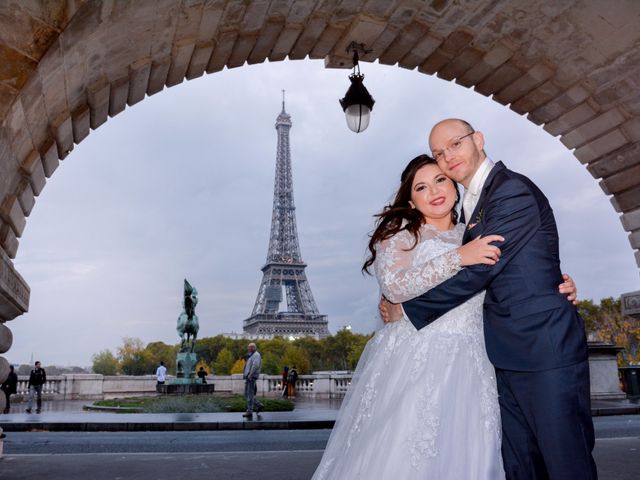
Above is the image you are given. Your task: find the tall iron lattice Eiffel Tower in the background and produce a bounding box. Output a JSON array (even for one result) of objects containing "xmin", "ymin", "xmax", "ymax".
[{"xmin": 243, "ymin": 94, "xmax": 329, "ymax": 338}]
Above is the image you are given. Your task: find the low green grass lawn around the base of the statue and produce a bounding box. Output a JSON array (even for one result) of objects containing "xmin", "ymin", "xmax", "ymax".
[{"xmin": 94, "ymin": 394, "xmax": 293, "ymax": 413}]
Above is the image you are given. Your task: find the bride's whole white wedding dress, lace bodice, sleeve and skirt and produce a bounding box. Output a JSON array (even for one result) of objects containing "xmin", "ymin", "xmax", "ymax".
[{"xmin": 313, "ymin": 225, "xmax": 504, "ymax": 480}]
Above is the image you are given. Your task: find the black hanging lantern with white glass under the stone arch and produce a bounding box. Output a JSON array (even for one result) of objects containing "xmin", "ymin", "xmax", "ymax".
[{"xmin": 340, "ymin": 42, "xmax": 376, "ymax": 133}]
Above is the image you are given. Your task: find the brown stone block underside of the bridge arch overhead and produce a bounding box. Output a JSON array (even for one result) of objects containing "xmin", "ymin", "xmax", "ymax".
[{"xmin": 0, "ymin": 0, "xmax": 640, "ymax": 326}]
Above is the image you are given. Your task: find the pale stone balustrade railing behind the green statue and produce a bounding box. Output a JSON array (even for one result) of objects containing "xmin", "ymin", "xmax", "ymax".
[{"xmin": 15, "ymin": 372, "xmax": 352, "ymax": 401}]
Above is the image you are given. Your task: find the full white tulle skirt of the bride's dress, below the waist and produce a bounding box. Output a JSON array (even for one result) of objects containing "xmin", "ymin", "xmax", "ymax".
[{"xmin": 313, "ymin": 320, "xmax": 504, "ymax": 480}]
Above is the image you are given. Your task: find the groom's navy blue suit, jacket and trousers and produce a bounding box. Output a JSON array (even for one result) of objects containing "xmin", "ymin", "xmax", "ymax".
[{"xmin": 403, "ymin": 162, "xmax": 597, "ymax": 480}]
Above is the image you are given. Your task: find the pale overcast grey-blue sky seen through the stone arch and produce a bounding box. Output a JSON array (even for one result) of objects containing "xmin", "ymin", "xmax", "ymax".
[{"xmin": 6, "ymin": 61, "xmax": 638, "ymax": 365}]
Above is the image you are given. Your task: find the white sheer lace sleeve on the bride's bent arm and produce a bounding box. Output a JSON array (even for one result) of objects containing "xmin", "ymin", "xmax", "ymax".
[{"xmin": 374, "ymin": 230, "xmax": 462, "ymax": 303}]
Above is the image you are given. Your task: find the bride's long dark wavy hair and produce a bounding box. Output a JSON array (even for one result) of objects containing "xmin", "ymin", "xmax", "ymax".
[{"xmin": 362, "ymin": 154, "xmax": 460, "ymax": 274}]
